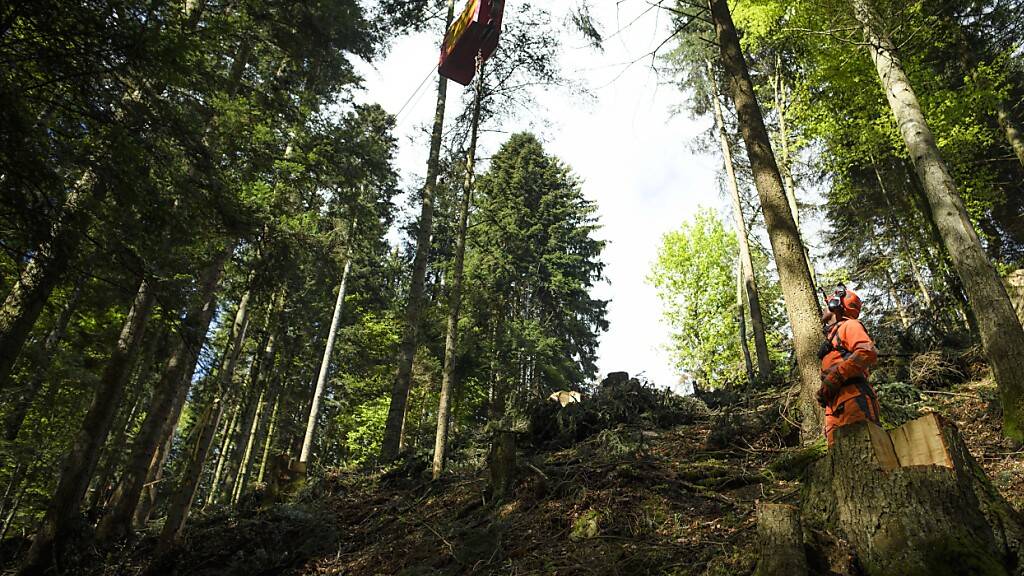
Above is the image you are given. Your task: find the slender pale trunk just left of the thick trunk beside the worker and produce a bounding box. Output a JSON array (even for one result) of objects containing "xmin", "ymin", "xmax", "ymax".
[{"xmin": 708, "ymin": 61, "xmax": 771, "ymax": 377}]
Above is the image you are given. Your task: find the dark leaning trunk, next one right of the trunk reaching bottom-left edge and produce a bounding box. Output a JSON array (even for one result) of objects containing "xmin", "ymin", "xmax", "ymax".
[{"xmin": 97, "ymin": 243, "xmax": 234, "ymax": 541}]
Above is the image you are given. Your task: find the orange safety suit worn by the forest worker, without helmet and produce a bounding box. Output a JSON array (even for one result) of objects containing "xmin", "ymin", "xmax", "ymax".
[{"xmin": 821, "ymin": 318, "xmax": 879, "ymax": 446}]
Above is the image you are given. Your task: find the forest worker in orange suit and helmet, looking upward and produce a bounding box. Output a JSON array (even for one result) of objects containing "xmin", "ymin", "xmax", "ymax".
[{"xmin": 818, "ymin": 284, "xmax": 879, "ymax": 446}]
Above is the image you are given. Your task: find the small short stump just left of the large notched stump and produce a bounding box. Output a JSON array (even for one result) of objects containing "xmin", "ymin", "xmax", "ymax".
[{"xmin": 754, "ymin": 502, "xmax": 808, "ymax": 576}]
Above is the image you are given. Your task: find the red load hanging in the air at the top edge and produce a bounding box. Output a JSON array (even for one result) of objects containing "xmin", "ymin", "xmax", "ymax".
[{"xmin": 437, "ymin": 0, "xmax": 505, "ymax": 86}]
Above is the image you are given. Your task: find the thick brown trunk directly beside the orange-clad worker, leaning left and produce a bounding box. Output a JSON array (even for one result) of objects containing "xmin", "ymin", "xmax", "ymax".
[{"xmin": 710, "ymin": 0, "xmax": 823, "ymax": 434}]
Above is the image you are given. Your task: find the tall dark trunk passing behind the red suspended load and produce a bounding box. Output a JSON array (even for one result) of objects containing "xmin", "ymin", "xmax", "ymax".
[{"xmin": 381, "ymin": 0, "xmax": 455, "ymax": 462}]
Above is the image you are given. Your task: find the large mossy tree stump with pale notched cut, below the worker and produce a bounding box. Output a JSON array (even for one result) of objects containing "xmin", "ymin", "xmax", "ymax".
[{"xmin": 802, "ymin": 414, "xmax": 1024, "ymax": 576}]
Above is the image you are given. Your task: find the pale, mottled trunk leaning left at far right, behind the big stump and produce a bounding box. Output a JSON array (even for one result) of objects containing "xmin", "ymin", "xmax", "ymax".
[{"xmin": 853, "ymin": 0, "xmax": 1024, "ymax": 441}]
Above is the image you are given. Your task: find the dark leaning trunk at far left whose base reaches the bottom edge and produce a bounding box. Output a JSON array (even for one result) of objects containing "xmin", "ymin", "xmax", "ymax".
[{"xmin": 20, "ymin": 280, "xmax": 154, "ymax": 575}]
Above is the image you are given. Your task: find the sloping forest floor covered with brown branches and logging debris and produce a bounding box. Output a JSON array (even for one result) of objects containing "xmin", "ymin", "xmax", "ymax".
[{"xmin": 102, "ymin": 368, "xmax": 1024, "ymax": 576}]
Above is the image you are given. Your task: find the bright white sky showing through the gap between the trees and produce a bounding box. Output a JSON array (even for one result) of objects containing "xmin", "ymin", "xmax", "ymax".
[{"xmin": 359, "ymin": 0, "xmax": 731, "ymax": 385}]
